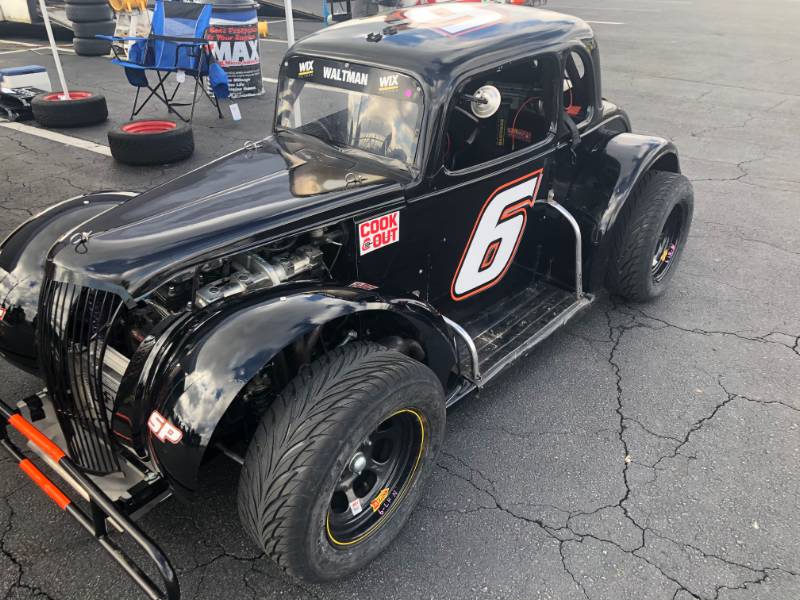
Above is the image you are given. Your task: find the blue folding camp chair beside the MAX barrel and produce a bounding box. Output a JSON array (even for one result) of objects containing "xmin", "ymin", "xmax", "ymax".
[{"xmin": 96, "ymin": 0, "xmax": 229, "ymax": 122}]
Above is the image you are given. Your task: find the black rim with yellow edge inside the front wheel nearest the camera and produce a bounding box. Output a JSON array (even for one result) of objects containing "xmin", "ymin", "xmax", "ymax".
[{"xmin": 326, "ymin": 409, "xmax": 425, "ymax": 546}]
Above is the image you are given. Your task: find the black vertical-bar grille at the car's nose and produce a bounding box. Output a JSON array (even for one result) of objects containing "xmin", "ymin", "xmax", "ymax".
[{"xmin": 38, "ymin": 280, "xmax": 122, "ymax": 473}]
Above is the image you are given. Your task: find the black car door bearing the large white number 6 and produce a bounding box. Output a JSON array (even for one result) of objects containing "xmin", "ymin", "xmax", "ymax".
[{"xmin": 405, "ymin": 156, "xmax": 548, "ymax": 320}]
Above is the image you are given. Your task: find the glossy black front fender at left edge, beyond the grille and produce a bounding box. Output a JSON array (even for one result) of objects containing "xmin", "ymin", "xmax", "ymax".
[{"xmin": 0, "ymin": 192, "xmax": 132, "ymax": 374}]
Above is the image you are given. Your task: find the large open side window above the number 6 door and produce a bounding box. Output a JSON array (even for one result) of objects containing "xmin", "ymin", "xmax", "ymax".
[{"xmin": 442, "ymin": 57, "xmax": 558, "ymax": 171}]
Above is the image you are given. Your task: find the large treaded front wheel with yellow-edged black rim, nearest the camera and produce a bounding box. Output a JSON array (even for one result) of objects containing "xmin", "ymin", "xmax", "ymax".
[{"xmin": 238, "ymin": 343, "xmax": 445, "ymax": 582}]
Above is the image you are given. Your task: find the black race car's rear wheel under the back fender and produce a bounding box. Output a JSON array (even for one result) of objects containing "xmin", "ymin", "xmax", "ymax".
[{"xmin": 606, "ymin": 170, "xmax": 694, "ymax": 302}]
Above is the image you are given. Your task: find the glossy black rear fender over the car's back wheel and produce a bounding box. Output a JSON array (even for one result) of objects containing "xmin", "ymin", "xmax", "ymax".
[{"xmin": 561, "ymin": 131, "xmax": 680, "ymax": 292}]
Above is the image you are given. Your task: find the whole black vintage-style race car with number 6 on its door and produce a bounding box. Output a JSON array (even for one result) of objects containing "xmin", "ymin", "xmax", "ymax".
[{"xmin": 0, "ymin": 3, "xmax": 693, "ymax": 598}]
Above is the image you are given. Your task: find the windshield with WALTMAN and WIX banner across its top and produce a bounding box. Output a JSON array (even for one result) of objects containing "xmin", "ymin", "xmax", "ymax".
[{"xmin": 275, "ymin": 56, "xmax": 422, "ymax": 166}]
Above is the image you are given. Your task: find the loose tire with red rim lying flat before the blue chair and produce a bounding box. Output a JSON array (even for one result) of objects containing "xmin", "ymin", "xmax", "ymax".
[{"xmin": 108, "ymin": 119, "xmax": 194, "ymax": 166}]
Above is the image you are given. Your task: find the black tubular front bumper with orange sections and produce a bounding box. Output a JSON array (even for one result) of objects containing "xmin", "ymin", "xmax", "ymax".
[{"xmin": 0, "ymin": 400, "xmax": 180, "ymax": 600}]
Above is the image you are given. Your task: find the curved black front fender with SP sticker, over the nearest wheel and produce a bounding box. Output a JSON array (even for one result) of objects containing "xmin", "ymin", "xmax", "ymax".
[{"xmin": 117, "ymin": 284, "xmax": 456, "ymax": 494}]
